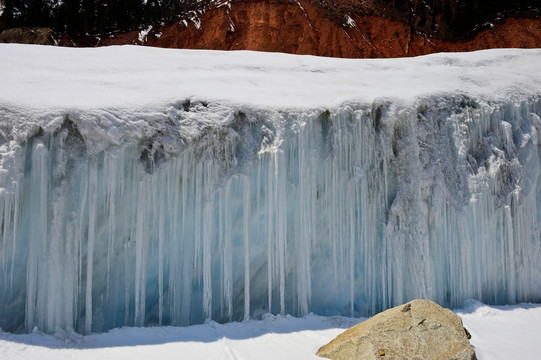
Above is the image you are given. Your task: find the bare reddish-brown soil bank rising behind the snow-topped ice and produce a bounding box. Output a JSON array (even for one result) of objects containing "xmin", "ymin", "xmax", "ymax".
[{"xmin": 1, "ymin": 0, "xmax": 541, "ymax": 58}]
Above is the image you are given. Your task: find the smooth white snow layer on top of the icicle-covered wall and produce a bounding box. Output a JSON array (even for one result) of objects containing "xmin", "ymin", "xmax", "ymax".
[{"xmin": 0, "ymin": 44, "xmax": 541, "ymax": 111}]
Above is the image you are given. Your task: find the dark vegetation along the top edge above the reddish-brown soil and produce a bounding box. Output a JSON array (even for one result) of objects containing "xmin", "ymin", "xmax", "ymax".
[{"xmin": 0, "ymin": 0, "xmax": 541, "ymax": 40}]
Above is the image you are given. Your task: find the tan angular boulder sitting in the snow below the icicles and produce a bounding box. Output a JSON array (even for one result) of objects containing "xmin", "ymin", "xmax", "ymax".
[{"xmin": 317, "ymin": 300, "xmax": 477, "ymax": 360}]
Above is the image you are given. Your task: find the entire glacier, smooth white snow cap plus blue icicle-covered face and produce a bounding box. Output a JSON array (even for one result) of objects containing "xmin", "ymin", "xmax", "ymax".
[{"xmin": 0, "ymin": 45, "xmax": 541, "ymax": 333}]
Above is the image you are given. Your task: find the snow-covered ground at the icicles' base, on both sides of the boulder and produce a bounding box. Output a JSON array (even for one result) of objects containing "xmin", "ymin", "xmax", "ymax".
[{"xmin": 0, "ymin": 300, "xmax": 541, "ymax": 360}]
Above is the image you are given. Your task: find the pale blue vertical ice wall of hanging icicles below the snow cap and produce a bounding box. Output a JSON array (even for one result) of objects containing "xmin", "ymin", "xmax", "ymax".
[{"xmin": 0, "ymin": 95, "xmax": 541, "ymax": 333}]
